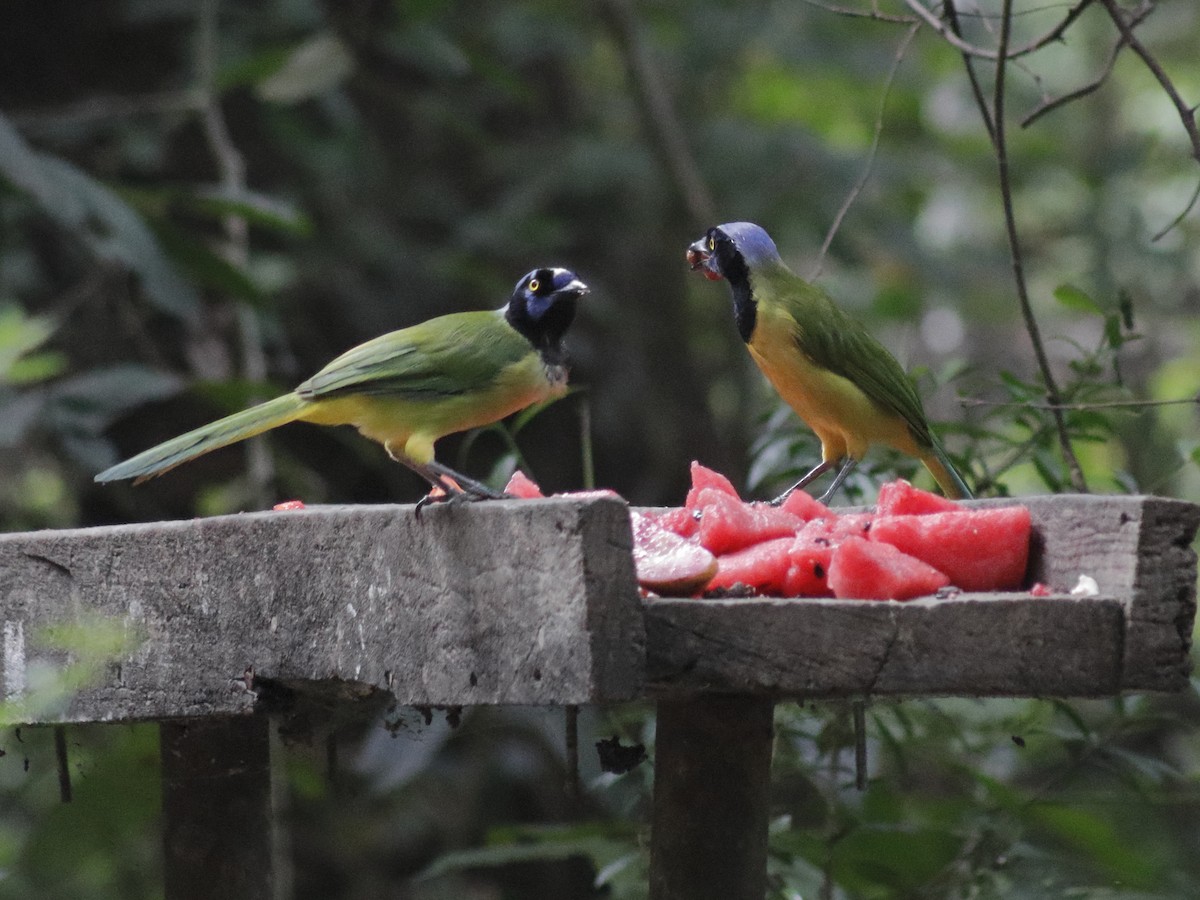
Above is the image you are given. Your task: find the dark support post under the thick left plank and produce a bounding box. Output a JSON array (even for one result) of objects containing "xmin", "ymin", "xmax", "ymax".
[{"xmin": 160, "ymin": 715, "xmax": 276, "ymax": 900}]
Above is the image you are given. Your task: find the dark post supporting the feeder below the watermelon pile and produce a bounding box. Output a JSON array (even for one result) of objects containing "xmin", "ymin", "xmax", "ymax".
[{"xmin": 650, "ymin": 696, "xmax": 775, "ymax": 900}]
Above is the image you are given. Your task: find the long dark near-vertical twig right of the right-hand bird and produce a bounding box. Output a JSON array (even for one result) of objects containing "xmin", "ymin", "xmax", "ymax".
[{"xmin": 991, "ymin": 0, "xmax": 1087, "ymax": 493}]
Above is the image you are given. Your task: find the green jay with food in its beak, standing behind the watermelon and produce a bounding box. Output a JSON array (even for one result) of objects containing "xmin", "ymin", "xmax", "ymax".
[{"xmin": 688, "ymin": 222, "xmax": 971, "ymax": 500}]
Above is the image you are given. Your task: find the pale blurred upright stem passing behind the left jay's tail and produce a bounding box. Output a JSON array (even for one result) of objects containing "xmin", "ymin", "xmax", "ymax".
[{"xmin": 197, "ymin": 0, "xmax": 275, "ymax": 506}]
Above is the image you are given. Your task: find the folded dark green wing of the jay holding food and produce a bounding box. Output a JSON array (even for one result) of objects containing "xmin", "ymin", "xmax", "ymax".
[{"xmin": 772, "ymin": 272, "xmax": 932, "ymax": 448}]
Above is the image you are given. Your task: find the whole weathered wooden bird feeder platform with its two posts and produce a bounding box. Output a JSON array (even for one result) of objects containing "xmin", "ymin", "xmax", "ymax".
[{"xmin": 0, "ymin": 496, "xmax": 1200, "ymax": 900}]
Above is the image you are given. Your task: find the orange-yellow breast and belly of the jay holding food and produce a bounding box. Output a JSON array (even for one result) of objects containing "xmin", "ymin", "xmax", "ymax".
[{"xmin": 746, "ymin": 304, "xmax": 917, "ymax": 461}]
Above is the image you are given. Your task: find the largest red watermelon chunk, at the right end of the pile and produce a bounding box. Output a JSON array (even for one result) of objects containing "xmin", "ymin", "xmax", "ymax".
[{"xmin": 870, "ymin": 506, "xmax": 1032, "ymax": 590}]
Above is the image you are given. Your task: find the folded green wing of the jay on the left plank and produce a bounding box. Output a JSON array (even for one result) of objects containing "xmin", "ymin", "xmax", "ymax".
[{"xmin": 296, "ymin": 312, "xmax": 534, "ymax": 400}]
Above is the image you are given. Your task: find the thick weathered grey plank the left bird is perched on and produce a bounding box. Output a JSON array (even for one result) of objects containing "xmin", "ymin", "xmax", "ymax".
[{"xmin": 0, "ymin": 499, "xmax": 643, "ymax": 721}]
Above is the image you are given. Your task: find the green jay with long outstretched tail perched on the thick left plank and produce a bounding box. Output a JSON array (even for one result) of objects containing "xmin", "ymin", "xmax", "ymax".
[{"xmin": 96, "ymin": 268, "xmax": 588, "ymax": 503}]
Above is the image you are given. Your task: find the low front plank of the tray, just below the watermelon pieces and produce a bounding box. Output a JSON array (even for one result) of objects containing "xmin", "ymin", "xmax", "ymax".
[{"xmin": 646, "ymin": 594, "xmax": 1124, "ymax": 697}]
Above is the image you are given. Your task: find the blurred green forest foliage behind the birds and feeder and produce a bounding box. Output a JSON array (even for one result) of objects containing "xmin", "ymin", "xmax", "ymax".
[{"xmin": 0, "ymin": 0, "xmax": 1200, "ymax": 900}]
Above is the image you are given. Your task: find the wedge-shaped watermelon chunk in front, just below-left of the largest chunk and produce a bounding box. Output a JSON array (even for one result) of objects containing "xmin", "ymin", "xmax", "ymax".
[{"xmin": 829, "ymin": 536, "xmax": 950, "ymax": 600}]
